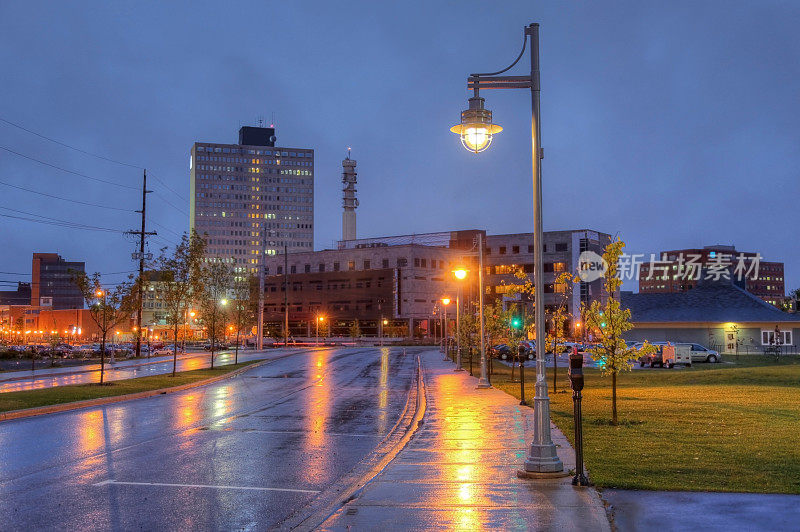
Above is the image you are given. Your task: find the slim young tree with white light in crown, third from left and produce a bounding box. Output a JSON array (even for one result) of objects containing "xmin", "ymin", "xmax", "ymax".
[{"xmin": 197, "ymin": 258, "xmax": 233, "ymax": 369}]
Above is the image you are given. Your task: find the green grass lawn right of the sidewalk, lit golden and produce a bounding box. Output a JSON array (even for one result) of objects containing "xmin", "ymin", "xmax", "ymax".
[{"xmin": 482, "ymin": 356, "xmax": 800, "ymax": 494}]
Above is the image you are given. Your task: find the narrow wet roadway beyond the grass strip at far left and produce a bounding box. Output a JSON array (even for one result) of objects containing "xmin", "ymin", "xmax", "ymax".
[{"xmin": 0, "ymin": 349, "xmax": 276, "ymax": 393}]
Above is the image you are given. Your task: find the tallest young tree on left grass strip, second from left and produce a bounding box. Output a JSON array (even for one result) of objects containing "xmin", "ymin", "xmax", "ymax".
[{"xmin": 154, "ymin": 231, "xmax": 206, "ymax": 377}]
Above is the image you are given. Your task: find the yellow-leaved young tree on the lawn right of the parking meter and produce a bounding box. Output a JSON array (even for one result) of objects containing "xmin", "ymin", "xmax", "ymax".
[{"xmin": 583, "ymin": 239, "xmax": 655, "ymax": 425}]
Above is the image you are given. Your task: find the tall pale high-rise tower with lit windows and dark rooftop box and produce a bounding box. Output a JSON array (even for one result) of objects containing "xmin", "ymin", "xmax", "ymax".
[{"xmin": 189, "ymin": 127, "xmax": 314, "ymax": 273}]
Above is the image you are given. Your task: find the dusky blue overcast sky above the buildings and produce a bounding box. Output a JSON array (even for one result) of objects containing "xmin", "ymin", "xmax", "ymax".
[{"xmin": 0, "ymin": 0, "xmax": 800, "ymax": 291}]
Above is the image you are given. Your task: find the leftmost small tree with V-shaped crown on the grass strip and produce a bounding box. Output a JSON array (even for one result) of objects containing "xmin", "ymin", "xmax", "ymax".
[{"xmin": 72, "ymin": 272, "xmax": 138, "ymax": 384}]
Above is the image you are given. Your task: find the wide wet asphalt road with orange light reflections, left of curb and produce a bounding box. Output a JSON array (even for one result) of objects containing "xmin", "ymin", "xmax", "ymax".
[{"xmin": 0, "ymin": 348, "xmax": 415, "ymax": 530}]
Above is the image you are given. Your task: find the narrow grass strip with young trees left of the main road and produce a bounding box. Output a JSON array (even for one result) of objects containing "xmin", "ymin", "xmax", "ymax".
[{"xmin": 0, "ymin": 361, "xmax": 256, "ymax": 412}]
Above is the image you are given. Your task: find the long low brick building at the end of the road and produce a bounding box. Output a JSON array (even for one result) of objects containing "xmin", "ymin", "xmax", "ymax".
[{"xmin": 264, "ymin": 230, "xmax": 611, "ymax": 336}]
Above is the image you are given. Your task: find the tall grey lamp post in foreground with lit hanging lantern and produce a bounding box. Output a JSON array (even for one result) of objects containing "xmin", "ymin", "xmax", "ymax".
[{"xmin": 450, "ymin": 23, "xmax": 564, "ymax": 476}]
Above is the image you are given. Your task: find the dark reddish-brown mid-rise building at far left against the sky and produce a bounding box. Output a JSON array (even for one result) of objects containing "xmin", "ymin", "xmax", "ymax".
[{"xmin": 30, "ymin": 253, "xmax": 86, "ymax": 310}]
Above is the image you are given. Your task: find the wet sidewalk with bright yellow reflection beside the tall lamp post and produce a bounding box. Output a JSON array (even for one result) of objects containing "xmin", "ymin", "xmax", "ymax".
[{"xmin": 320, "ymin": 351, "xmax": 610, "ymax": 530}]
